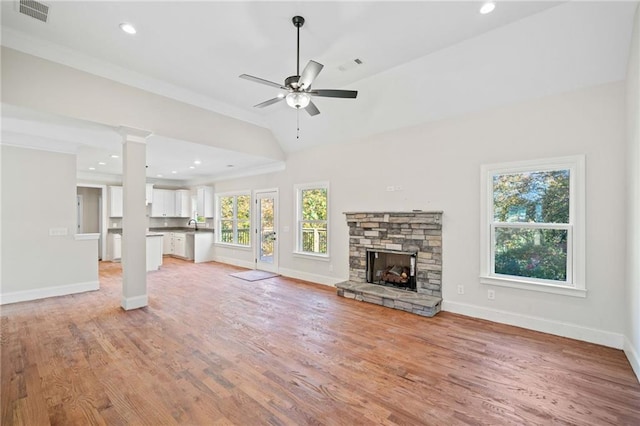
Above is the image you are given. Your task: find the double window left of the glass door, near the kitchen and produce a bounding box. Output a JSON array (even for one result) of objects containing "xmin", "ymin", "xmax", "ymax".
[{"xmin": 216, "ymin": 193, "xmax": 251, "ymax": 246}]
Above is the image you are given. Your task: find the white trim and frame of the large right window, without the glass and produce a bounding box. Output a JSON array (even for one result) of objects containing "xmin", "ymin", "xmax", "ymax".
[{"xmin": 480, "ymin": 155, "xmax": 587, "ymax": 297}]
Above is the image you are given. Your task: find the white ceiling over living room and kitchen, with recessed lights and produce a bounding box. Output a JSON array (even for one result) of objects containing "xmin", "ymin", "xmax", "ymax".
[{"xmin": 1, "ymin": 1, "xmax": 637, "ymax": 180}]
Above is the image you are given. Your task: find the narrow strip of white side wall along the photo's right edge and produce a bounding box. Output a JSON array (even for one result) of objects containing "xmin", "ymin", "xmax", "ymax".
[{"xmin": 624, "ymin": 8, "xmax": 640, "ymax": 379}]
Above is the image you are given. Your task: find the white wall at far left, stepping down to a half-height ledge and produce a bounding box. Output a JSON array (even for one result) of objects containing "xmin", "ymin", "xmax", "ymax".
[{"xmin": 0, "ymin": 146, "xmax": 99, "ymax": 303}]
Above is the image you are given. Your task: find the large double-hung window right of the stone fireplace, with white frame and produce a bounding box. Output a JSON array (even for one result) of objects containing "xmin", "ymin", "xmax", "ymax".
[{"xmin": 480, "ymin": 157, "xmax": 586, "ymax": 297}]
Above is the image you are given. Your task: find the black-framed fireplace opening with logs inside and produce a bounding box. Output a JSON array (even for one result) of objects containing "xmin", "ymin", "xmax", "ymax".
[{"xmin": 366, "ymin": 250, "xmax": 418, "ymax": 291}]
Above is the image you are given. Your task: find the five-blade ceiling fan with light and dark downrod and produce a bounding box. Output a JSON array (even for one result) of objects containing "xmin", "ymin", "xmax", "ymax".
[{"xmin": 240, "ymin": 16, "xmax": 358, "ymax": 116}]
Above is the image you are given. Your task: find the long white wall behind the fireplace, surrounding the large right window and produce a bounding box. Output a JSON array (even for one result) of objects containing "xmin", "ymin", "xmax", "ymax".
[{"xmin": 216, "ymin": 82, "xmax": 625, "ymax": 348}]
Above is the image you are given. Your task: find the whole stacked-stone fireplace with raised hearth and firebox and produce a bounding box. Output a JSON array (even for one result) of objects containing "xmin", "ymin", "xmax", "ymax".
[{"xmin": 336, "ymin": 211, "xmax": 442, "ymax": 316}]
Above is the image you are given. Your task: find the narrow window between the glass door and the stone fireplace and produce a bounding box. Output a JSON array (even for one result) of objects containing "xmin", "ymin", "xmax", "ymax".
[{"xmin": 296, "ymin": 183, "xmax": 329, "ymax": 256}]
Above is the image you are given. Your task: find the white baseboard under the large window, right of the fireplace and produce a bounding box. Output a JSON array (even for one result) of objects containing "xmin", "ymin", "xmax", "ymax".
[{"xmin": 442, "ymin": 300, "xmax": 624, "ymax": 349}]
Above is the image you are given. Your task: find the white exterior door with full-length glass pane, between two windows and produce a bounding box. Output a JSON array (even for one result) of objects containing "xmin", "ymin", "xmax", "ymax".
[{"xmin": 256, "ymin": 190, "xmax": 278, "ymax": 273}]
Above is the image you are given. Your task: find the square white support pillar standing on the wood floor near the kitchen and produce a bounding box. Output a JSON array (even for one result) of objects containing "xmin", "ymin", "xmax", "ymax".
[{"xmin": 119, "ymin": 127, "xmax": 151, "ymax": 311}]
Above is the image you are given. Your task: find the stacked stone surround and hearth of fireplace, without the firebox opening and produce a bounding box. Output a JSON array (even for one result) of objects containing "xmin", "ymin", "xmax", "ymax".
[{"xmin": 336, "ymin": 211, "xmax": 442, "ymax": 316}]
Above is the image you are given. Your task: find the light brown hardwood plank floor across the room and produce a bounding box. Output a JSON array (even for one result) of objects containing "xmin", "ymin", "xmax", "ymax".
[{"xmin": 0, "ymin": 258, "xmax": 640, "ymax": 425}]
